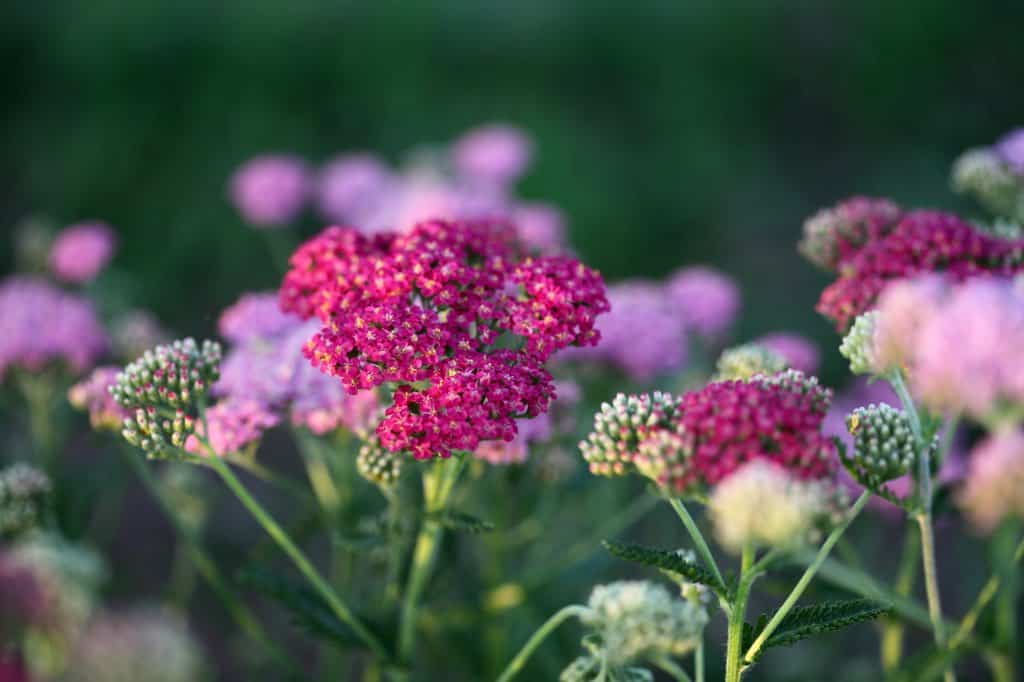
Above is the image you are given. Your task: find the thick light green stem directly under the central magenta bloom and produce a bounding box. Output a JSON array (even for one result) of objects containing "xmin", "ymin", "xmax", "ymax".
[{"xmin": 398, "ymin": 455, "xmax": 467, "ymax": 664}]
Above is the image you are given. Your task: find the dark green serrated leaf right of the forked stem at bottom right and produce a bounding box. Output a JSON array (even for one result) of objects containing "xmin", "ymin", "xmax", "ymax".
[{"xmin": 743, "ymin": 599, "xmax": 890, "ymax": 663}]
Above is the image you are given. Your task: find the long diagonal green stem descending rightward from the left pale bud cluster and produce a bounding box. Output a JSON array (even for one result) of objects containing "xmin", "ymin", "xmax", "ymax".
[{"xmin": 209, "ymin": 456, "xmax": 389, "ymax": 659}]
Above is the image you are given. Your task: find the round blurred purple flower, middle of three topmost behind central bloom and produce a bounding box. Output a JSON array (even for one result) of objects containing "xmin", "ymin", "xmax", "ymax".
[{"xmin": 317, "ymin": 154, "xmax": 397, "ymax": 223}]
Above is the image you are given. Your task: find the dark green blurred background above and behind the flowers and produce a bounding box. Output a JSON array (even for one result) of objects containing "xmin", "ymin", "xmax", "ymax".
[{"xmin": 0, "ymin": 0, "xmax": 1024, "ymax": 370}]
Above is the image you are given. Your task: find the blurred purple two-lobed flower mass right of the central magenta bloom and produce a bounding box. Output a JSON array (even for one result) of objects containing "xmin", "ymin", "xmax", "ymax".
[{"xmin": 560, "ymin": 266, "xmax": 739, "ymax": 382}]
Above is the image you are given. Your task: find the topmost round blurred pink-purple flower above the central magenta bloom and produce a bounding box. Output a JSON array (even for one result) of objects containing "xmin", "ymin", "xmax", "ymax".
[{"xmin": 452, "ymin": 124, "xmax": 532, "ymax": 186}]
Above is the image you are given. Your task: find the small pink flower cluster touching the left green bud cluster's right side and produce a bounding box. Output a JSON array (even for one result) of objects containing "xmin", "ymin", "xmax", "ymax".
[{"xmin": 184, "ymin": 399, "xmax": 281, "ymax": 456}]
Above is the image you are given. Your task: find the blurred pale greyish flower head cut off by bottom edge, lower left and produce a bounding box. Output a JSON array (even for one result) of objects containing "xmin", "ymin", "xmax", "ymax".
[{"xmin": 61, "ymin": 608, "xmax": 205, "ymax": 682}]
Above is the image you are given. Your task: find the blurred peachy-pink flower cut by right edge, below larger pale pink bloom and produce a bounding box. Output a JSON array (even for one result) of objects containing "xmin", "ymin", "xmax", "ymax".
[{"xmin": 958, "ymin": 428, "xmax": 1024, "ymax": 532}]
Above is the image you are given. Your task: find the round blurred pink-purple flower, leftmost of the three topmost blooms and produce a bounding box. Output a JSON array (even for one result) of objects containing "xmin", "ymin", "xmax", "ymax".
[{"xmin": 230, "ymin": 155, "xmax": 311, "ymax": 227}]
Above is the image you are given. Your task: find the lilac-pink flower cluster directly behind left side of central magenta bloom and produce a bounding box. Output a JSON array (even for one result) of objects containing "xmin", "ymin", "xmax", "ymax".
[{"xmin": 213, "ymin": 293, "xmax": 377, "ymax": 434}]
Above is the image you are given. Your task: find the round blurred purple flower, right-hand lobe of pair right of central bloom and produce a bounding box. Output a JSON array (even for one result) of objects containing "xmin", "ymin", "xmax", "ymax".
[{"xmin": 668, "ymin": 265, "xmax": 739, "ymax": 340}]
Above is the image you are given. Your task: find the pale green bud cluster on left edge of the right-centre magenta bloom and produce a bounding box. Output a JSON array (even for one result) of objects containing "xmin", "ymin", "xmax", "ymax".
[{"xmin": 580, "ymin": 391, "xmax": 679, "ymax": 476}]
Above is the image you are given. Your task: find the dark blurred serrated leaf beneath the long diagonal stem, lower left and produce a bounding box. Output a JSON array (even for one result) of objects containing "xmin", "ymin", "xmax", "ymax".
[{"xmin": 239, "ymin": 568, "xmax": 391, "ymax": 648}]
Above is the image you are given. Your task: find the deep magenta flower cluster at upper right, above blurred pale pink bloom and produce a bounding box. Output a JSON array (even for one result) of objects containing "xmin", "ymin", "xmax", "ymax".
[{"xmin": 804, "ymin": 200, "xmax": 1024, "ymax": 330}]
